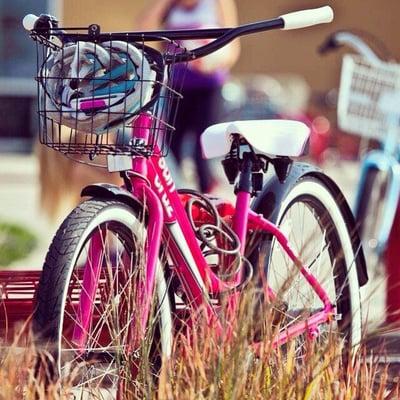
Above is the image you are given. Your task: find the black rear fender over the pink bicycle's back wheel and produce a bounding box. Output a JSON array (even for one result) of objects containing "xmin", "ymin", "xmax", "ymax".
[{"xmin": 251, "ymin": 162, "xmax": 368, "ymax": 287}]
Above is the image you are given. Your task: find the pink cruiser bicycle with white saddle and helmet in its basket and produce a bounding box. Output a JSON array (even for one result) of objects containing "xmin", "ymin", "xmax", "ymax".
[{"xmin": 24, "ymin": 7, "xmax": 367, "ymax": 397}]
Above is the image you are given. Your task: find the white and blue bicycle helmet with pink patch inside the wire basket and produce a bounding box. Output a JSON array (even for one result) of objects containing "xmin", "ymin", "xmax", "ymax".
[{"xmin": 41, "ymin": 41, "xmax": 156, "ymax": 134}]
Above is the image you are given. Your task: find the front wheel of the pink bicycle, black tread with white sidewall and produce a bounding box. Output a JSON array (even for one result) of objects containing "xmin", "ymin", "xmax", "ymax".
[{"xmin": 33, "ymin": 199, "xmax": 172, "ymax": 399}]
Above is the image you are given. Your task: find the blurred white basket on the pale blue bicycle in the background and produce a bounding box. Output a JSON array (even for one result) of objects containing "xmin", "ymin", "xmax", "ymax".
[{"xmin": 338, "ymin": 55, "xmax": 400, "ymax": 141}]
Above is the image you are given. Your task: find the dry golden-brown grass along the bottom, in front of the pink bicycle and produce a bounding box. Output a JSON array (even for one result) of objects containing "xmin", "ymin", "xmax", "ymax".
[{"xmin": 0, "ymin": 290, "xmax": 400, "ymax": 400}]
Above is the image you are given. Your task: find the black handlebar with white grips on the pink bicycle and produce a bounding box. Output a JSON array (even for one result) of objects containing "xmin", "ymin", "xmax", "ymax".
[{"xmin": 22, "ymin": 6, "xmax": 333, "ymax": 62}]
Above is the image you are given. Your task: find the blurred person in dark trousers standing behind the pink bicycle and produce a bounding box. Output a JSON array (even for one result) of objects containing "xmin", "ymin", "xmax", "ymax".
[{"xmin": 137, "ymin": 0, "xmax": 240, "ymax": 193}]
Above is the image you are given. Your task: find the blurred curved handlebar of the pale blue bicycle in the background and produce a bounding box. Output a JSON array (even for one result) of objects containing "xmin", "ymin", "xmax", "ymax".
[{"xmin": 318, "ymin": 31, "xmax": 382, "ymax": 63}]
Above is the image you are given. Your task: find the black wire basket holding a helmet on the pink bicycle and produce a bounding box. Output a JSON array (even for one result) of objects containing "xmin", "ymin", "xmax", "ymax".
[{"xmin": 31, "ymin": 25, "xmax": 186, "ymax": 161}]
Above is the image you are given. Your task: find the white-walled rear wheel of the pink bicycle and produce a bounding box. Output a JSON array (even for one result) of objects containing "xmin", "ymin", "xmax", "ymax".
[{"xmin": 266, "ymin": 176, "xmax": 361, "ymax": 346}]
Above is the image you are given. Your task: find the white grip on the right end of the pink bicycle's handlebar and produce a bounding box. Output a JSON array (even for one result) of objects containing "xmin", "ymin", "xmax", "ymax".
[{"xmin": 279, "ymin": 6, "xmax": 333, "ymax": 30}]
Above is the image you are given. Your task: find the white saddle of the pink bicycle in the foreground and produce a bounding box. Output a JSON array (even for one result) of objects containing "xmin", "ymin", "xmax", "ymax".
[{"xmin": 200, "ymin": 119, "xmax": 310, "ymax": 158}]
